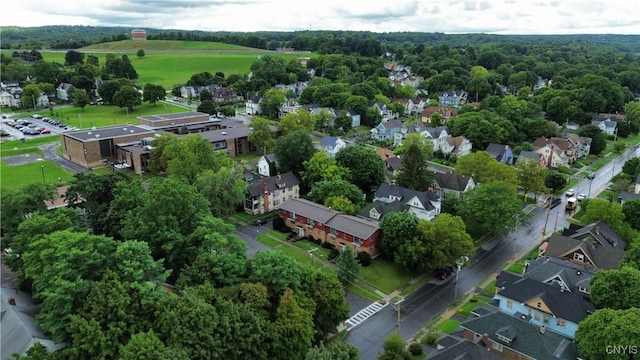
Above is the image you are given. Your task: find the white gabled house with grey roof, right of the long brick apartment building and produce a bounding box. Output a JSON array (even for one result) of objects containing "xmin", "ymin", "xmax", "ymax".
[{"xmin": 374, "ymin": 183, "xmax": 442, "ymax": 220}]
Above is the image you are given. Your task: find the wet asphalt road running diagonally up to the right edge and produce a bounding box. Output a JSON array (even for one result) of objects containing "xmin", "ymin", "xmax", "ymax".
[{"xmin": 345, "ymin": 148, "xmax": 640, "ymax": 360}]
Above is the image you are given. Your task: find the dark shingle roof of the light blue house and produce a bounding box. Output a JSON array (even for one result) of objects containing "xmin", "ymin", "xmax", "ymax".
[{"xmin": 498, "ymin": 271, "xmax": 595, "ymax": 324}]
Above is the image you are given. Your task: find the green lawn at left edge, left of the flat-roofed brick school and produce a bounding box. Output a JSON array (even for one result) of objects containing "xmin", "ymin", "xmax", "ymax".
[{"xmin": 0, "ymin": 160, "xmax": 73, "ymax": 189}]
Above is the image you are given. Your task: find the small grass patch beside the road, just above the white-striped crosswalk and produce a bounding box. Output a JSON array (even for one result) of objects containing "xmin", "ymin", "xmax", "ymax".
[{"xmin": 359, "ymin": 257, "xmax": 411, "ymax": 294}]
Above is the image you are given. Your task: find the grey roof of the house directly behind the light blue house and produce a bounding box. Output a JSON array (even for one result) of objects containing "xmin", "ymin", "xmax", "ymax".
[{"xmin": 524, "ymin": 256, "xmax": 596, "ymax": 291}]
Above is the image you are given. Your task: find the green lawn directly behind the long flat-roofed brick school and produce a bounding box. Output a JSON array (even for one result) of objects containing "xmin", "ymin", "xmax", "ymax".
[{"xmin": 15, "ymin": 102, "xmax": 189, "ymax": 129}]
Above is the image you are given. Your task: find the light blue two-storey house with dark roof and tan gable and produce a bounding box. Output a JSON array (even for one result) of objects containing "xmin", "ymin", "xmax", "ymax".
[{"xmin": 494, "ymin": 271, "xmax": 595, "ymax": 339}]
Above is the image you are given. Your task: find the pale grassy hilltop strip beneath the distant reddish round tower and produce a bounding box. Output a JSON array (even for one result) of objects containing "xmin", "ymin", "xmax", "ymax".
[{"xmin": 80, "ymin": 40, "xmax": 265, "ymax": 53}]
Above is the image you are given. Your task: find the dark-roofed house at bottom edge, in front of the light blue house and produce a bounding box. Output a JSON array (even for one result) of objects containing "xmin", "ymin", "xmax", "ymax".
[{"xmin": 460, "ymin": 312, "xmax": 579, "ymax": 360}]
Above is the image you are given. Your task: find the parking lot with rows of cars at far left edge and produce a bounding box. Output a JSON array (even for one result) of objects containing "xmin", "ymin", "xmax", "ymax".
[{"xmin": 2, "ymin": 114, "xmax": 75, "ymax": 140}]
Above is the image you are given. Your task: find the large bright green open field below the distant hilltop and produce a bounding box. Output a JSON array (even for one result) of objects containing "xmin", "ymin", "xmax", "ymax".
[{"xmin": 41, "ymin": 49, "xmax": 313, "ymax": 90}]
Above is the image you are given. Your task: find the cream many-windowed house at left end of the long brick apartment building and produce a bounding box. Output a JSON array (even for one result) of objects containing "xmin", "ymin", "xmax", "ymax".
[{"xmin": 244, "ymin": 172, "xmax": 300, "ymax": 215}]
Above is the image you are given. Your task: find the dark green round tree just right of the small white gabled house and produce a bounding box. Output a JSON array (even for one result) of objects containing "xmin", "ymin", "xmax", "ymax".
[{"xmin": 274, "ymin": 130, "xmax": 316, "ymax": 176}]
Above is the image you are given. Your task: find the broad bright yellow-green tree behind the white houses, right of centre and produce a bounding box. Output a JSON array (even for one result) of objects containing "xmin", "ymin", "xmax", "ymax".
[{"xmin": 456, "ymin": 151, "xmax": 518, "ymax": 185}]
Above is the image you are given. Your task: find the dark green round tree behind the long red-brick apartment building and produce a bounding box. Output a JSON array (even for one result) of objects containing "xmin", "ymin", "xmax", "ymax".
[{"xmin": 336, "ymin": 145, "xmax": 385, "ymax": 194}]
